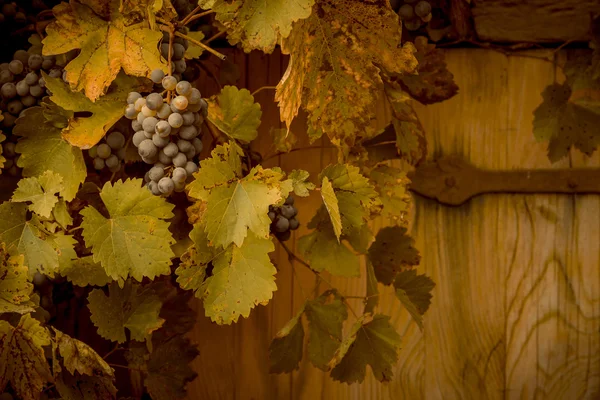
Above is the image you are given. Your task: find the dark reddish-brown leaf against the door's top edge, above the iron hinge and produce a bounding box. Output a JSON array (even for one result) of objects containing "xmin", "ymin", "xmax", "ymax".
[{"xmin": 400, "ymin": 36, "xmax": 458, "ymax": 104}]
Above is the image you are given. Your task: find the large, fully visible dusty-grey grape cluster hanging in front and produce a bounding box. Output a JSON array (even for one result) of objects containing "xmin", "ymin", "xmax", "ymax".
[{"xmin": 124, "ymin": 69, "xmax": 208, "ymax": 196}]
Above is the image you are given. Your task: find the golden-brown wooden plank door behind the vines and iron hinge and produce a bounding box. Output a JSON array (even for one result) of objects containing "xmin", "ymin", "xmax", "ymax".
[{"xmin": 188, "ymin": 50, "xmax": 600, "ymax": 400}]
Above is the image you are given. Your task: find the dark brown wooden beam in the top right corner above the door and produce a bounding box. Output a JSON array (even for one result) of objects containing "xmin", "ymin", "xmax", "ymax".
[{"xmin": 471, "ymin": 0, "xmax": 600, "ymax": 43}]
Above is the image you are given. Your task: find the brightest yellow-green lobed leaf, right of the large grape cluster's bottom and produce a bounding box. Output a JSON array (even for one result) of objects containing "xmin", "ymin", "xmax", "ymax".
[{"xmin": 188, "ymin": 143, "xmax": 291, "ymax": 248}]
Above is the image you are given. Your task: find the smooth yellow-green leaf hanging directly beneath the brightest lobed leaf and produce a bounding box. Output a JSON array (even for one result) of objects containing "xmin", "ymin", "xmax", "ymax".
[{"xmin": 202, "ymin": 234, "xmax": 277, "ymax": 324}]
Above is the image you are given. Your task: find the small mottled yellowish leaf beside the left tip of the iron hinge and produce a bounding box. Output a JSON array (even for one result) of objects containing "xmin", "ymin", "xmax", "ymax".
[{"xmin": 369, "ymin": 165, "xmax": 411, "ymax": 224}]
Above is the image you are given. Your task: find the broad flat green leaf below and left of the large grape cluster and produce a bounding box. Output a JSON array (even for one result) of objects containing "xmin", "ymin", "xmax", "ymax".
[{"xmin": 81, "ymin": 179, "xmax": 174, "ymax": 282}]
